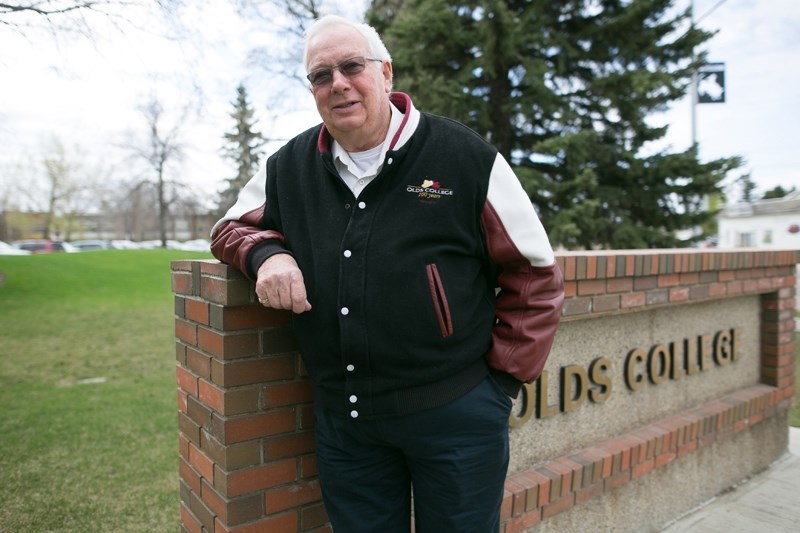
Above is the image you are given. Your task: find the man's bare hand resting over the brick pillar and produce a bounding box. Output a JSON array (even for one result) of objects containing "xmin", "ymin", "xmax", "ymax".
[{"xmin": 256, "ymin": 254, "xmax": 311, "ymax": 313}]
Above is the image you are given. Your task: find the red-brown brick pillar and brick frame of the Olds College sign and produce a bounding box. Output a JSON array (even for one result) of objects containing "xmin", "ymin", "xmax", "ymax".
[{"xmin": 172, "ymin": 250, "xmax": 800, "ymax": 533}]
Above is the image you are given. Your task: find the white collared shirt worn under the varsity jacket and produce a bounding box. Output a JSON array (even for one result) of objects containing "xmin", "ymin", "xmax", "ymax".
[{"xmin": 331, "ymin": 102, "xmax": 403, "ymax": 198}]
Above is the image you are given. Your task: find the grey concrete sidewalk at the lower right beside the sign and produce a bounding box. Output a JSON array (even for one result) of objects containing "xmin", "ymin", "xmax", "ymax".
[{"xmin": 662, "ymin": 428, "xmax": 800, "ymax": 533}]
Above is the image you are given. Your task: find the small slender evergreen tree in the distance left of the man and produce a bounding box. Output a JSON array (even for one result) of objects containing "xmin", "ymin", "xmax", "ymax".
[{"xmin": 218, "ymin": 83, "xmax": 267, "ymax": 216}]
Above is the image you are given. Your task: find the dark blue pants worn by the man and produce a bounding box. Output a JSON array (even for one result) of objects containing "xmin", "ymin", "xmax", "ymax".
[{"xmin": 316, "ymin": 377, "xmax": 511, "ymax": 533}]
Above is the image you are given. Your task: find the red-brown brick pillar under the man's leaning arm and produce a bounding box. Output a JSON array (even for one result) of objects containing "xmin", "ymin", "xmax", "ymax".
[{"xmin": 172, "ymin": 261, "xmax": 330, "ymax": 533}]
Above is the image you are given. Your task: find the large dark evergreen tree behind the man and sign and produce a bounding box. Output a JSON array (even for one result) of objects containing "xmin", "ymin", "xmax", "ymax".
[{"xmin": 367, "ymin": 0, "xmax": 741, "ymax": 248}]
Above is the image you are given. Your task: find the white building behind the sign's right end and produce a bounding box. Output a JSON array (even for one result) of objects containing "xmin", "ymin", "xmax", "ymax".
[{"xmin": 718, "ymin": 191, "xmax": 800, "ymax": 250}]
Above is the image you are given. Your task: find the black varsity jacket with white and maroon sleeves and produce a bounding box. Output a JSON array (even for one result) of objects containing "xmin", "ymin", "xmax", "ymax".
[{"xmin": 211, "ymin": 93, "xmax": 563, "ymax": 418}]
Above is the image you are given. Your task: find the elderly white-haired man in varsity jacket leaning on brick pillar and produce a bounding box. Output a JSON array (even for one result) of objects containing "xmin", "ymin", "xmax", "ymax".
[{"xmin": 212, "ymin": 12, "xmax": 563, "ymax": 533}]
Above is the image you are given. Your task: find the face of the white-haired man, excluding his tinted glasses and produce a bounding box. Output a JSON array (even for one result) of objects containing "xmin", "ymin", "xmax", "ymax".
[{"xmin": 308, "ymin": 26, "xmax": 392, "ymax": 151}]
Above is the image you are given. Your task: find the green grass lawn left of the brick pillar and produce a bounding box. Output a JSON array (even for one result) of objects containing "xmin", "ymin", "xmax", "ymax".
[{"xmin": 0, "ymin": 250, "xmax": 210, "ymax": 533}]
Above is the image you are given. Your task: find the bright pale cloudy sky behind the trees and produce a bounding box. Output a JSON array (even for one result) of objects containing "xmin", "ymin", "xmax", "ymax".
[{"xmin": 0, "ymin": 0, "xmax": 800, "ymax": 212}]
